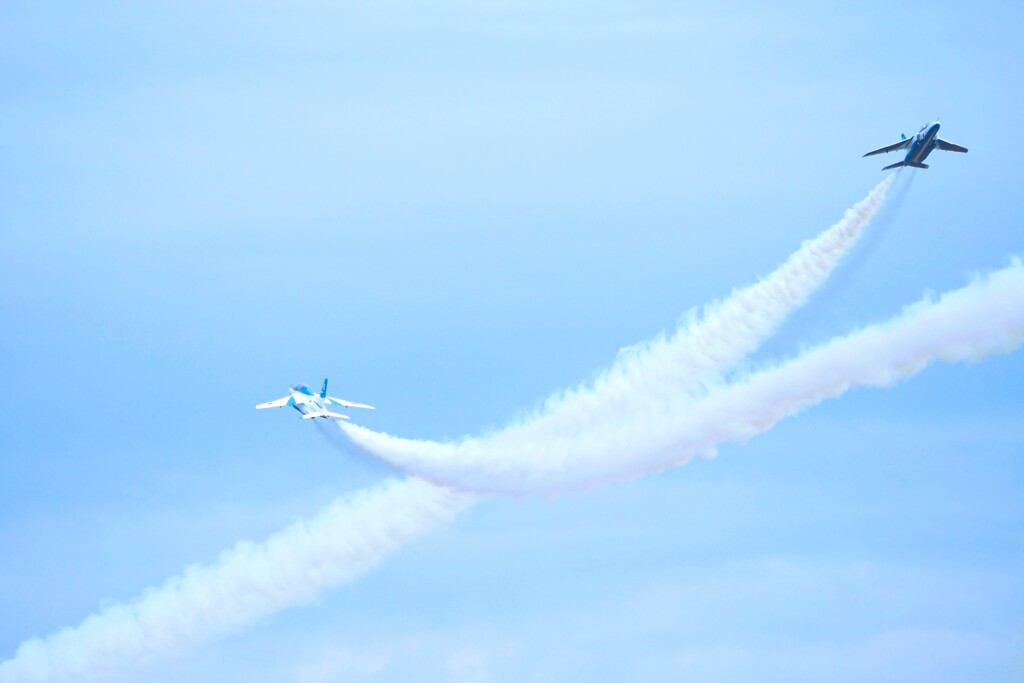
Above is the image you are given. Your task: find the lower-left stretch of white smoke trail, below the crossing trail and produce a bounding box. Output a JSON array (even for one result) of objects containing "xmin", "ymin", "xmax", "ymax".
[{"xmin": 0, "ymin": 478, "xmax": 473, "ymax": 683}]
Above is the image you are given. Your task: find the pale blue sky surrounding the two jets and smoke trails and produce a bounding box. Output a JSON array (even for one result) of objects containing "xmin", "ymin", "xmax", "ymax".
[{"xmin": 0, "ymin": 2, "xmax": 1024, "ymax": 682}]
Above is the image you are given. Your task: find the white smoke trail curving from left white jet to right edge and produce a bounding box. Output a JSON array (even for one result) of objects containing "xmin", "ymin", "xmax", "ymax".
[{"xmin": 343, "ymin": 260, "xmax": 1024, "ymax": 494}]
